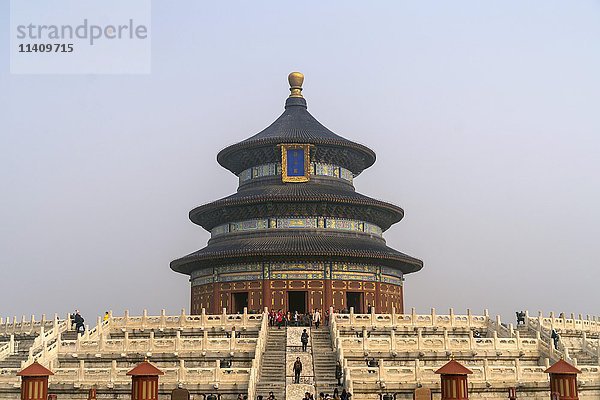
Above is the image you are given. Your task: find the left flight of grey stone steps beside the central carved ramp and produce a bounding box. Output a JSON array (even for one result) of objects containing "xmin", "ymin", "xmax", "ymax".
[{"xmin": 256, "ymin": 327, "xmax": 287, "ymax": 400}]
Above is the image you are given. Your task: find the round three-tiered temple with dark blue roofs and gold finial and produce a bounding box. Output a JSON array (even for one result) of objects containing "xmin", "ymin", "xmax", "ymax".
[{"xmin": 171, "ymin": 72, "xmax": 423, "ymax": 314}]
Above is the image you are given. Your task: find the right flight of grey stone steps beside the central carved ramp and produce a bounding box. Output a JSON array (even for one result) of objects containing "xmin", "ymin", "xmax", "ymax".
[{"xmin": 311, "ymin": 327, "xmax": 341, "ymax": 395}]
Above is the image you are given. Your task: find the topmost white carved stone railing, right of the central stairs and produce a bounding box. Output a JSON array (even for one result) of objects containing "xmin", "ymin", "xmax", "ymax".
[{"xmin": 332, "ymin": 308, "xmax": 489, "ymax": 329}]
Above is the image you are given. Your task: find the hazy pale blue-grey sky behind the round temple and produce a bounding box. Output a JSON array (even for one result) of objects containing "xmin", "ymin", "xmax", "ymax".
[{"xmin": 0, "ymin": 0, "xmax": 600, "ymax": 322}]
